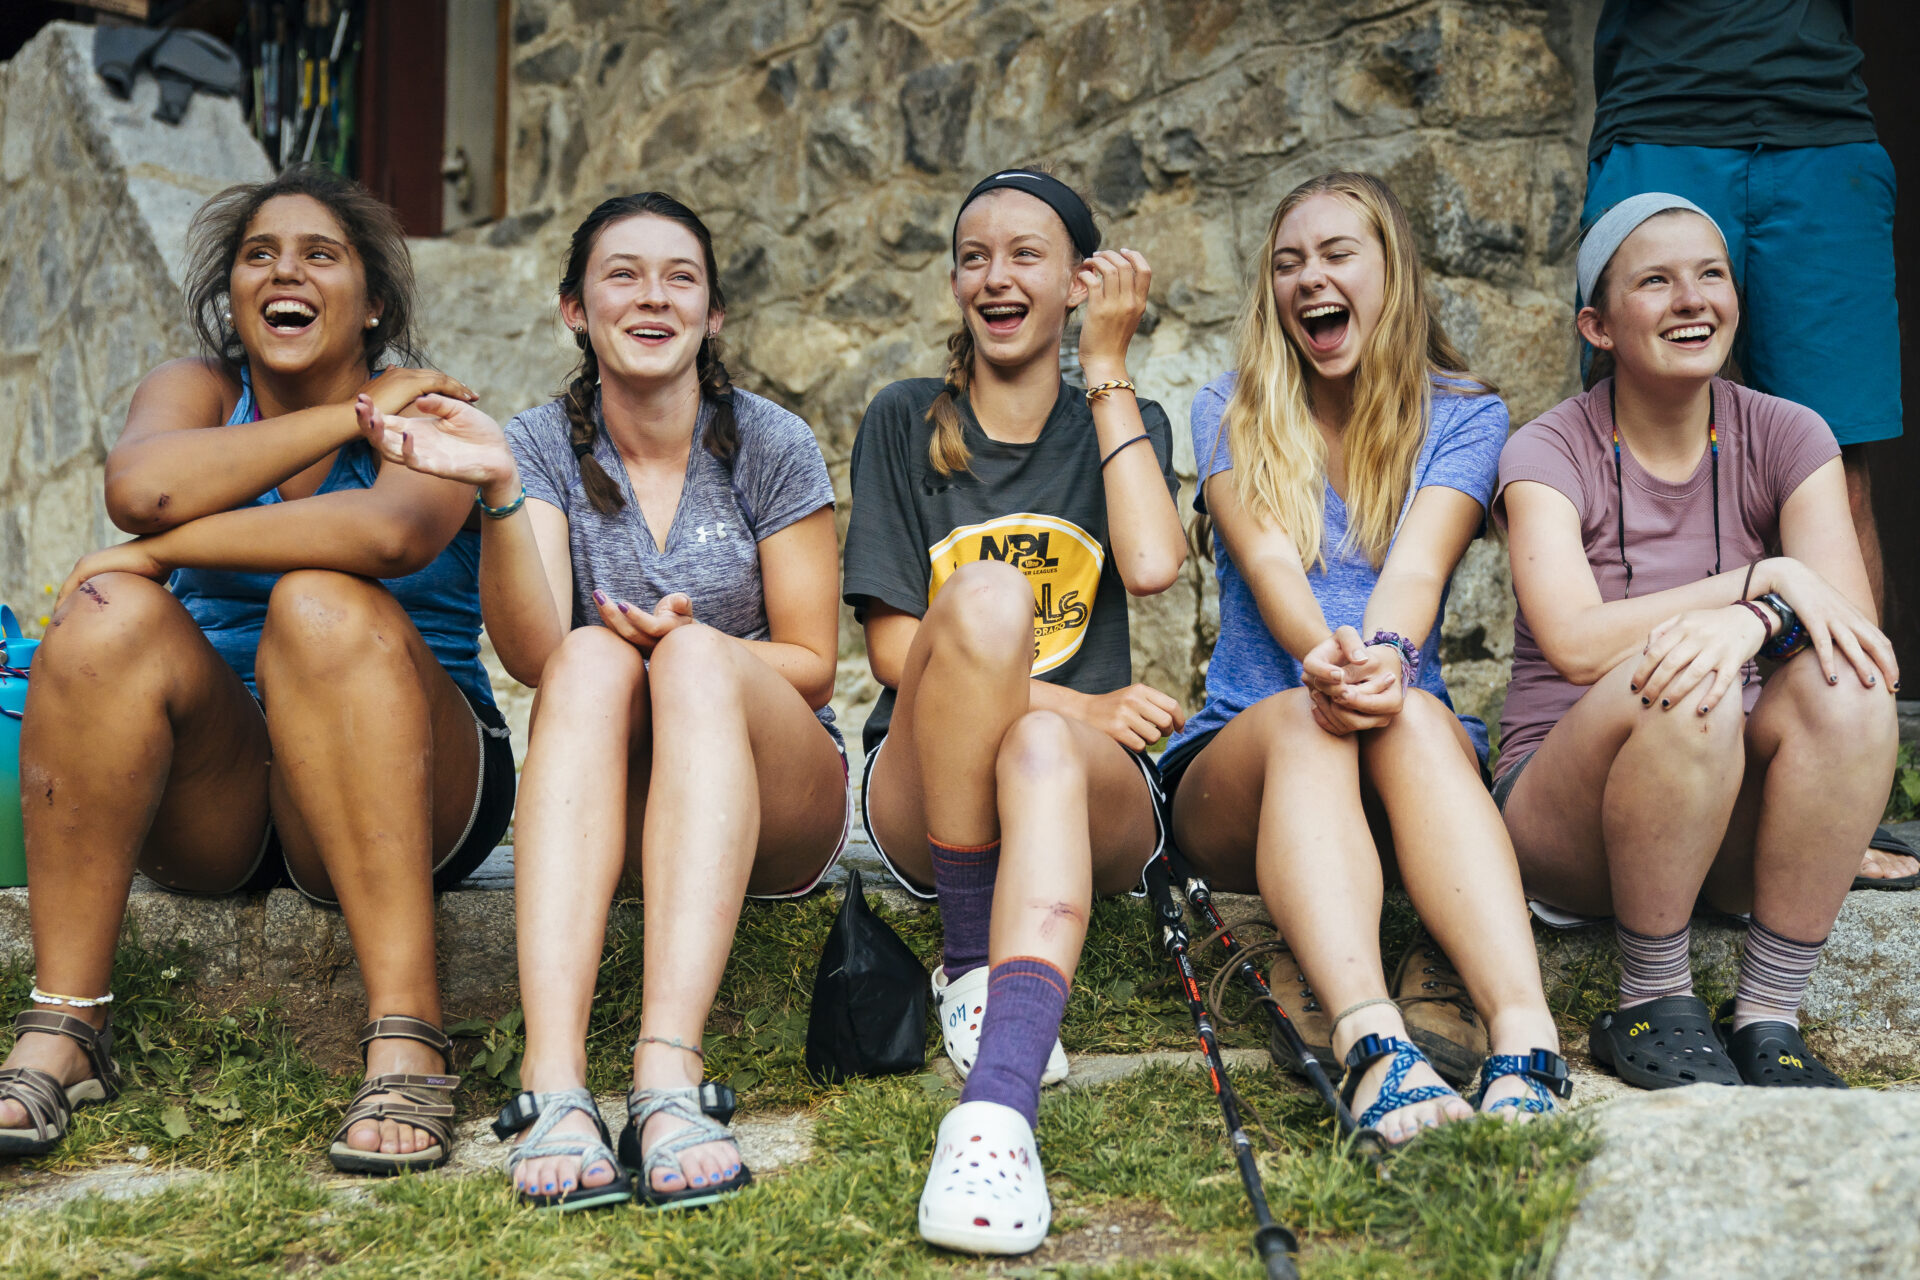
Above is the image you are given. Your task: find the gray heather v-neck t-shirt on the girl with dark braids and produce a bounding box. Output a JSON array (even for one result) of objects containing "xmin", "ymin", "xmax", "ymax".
[{"xmin": 507, "ymin": 390, "xmax": 833, "ymax": 723}]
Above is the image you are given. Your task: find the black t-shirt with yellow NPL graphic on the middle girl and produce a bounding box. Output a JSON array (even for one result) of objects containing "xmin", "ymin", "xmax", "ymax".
[{"xmin": 841, "ymin": 378, "xmax": 1179, "ymax": 750}]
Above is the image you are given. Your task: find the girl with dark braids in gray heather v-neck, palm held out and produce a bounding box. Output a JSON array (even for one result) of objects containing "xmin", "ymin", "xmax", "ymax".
[{"xmin": 363, "ymin": 192, "xmax": 851, "ymax": 1209}]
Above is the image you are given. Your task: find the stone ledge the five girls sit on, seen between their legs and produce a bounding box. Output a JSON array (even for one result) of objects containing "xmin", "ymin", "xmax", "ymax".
[{"xmin": 0, "ymin": 821, "xmax": 1920, "ymax": 1032}]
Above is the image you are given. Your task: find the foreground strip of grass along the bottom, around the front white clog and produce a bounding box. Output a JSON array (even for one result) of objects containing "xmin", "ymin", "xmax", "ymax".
[{"xmin": 0, "ymin": 1067, "xmax": 1594, "ymax": 1280}]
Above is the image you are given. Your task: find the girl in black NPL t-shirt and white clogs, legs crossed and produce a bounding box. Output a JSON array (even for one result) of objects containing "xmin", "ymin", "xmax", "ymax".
[{"xmin": 843, "ymin": 169, "xmax": 1187, "ymax": 1253}]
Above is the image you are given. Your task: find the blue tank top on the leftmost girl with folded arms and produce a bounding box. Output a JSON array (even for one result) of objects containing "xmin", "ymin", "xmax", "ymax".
[{"xmin": 167, "ymin": 368, "xmax": 493, "ymax": 706}]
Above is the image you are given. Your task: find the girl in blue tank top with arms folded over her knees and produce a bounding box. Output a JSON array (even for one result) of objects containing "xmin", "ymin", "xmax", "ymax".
[{"xmin": 0, "ymin": 167, "xmax": 513, "ymax": 1173}]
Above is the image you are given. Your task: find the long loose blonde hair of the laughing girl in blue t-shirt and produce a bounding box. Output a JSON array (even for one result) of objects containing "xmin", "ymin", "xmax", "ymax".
[{"xmin": 1202, "ymin": 173, "xmax": 1496, "ymax": 568}]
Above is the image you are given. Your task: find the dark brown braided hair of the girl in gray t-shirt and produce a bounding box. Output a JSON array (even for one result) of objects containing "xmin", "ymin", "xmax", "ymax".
[{"xmin": 559, "ymin": 192, "xmax": 739, "ymax": 516}]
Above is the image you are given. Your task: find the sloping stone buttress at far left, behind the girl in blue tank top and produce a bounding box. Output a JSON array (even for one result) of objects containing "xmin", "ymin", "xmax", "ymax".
[{"xmin": 0, "ymin": 23, "xmax": 269, "ymax": 628}]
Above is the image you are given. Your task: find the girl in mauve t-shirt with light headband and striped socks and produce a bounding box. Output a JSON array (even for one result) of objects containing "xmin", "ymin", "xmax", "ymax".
[{"xmin": 1494, "ymin": 194, "xmax": 1899, "ymax": 1088}]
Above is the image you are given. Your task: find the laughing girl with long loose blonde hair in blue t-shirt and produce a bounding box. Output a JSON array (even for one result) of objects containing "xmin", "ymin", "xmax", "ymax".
[{"xmin": 1162, "ymin": 173, "xmax": 1567, "ymax": 1142}]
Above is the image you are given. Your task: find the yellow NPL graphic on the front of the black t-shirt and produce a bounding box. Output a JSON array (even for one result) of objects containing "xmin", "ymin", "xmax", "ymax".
[{"xmin": 927, "ymin": 510, "xmax": 1106, "ymax": 676}]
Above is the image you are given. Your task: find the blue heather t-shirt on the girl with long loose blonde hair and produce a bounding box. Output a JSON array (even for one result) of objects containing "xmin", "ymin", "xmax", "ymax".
[{"xmin": 1167, "ymin": 372, "xmax": 1507, "ymax": 764}]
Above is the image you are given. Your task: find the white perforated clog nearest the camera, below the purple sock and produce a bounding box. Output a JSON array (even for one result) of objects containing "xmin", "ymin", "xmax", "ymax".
[{"xmin": 920, "ymin": 1102, "xmax": 1054, "ymax": 1253}]
